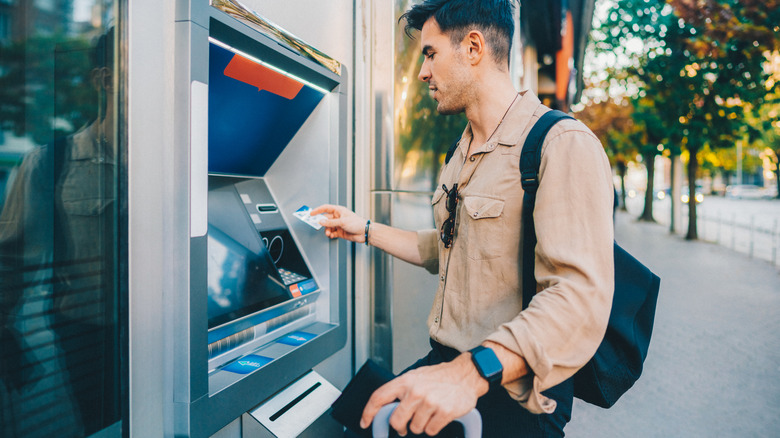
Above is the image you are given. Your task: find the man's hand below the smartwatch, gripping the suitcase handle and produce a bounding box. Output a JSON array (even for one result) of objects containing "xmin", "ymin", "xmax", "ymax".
[{"xmin": 360, "ymin": 353, "xmax": 489, "ymax": 436}]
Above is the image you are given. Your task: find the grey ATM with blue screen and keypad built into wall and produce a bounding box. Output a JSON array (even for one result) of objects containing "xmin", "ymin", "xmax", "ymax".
[{"xmin": 177, "ymin": 0, "xmax": 348, "ymax": 437}]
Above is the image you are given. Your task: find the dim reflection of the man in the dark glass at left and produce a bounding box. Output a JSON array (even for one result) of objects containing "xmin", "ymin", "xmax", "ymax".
[{"xmin": 0, "ymin": 29, "xmax": 119, "ymax": 436}]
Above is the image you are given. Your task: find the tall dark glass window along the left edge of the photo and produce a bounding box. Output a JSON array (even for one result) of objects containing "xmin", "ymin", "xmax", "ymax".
[{"xmin": 0, "ymin": 0, "xmax": 127, "ymax": 438}]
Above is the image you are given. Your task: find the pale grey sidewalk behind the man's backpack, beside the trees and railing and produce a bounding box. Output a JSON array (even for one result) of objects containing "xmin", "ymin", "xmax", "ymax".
[{"xmin": 566, "ymin": 213, "xmax": 780, "ymax": 438}]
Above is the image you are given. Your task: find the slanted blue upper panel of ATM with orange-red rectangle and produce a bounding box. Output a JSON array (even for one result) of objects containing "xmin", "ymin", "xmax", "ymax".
[{"xmin": 209, "ymin": 43, "xmax": 324, "ymax": 176}]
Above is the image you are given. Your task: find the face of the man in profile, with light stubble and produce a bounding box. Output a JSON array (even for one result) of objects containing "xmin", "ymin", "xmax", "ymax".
[{"xmin": 417, "ymin": 18, "xmax": 474, "ymax": 114}]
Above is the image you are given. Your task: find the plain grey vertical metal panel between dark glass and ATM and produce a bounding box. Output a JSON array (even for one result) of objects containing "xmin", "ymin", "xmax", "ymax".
[{"xmin": 127, "ymin": 0, "xmax": 176, "ymax": 436}]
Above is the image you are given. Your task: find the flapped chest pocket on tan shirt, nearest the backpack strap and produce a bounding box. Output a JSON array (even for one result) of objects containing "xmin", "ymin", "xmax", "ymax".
[{"xmin": 458, "ymin": 196, "xmax": 505, "ymax": 260}]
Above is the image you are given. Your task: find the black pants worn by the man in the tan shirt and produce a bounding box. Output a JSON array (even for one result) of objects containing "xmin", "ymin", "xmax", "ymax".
[{"xmin": 401, "ymin": 340, "xmax": 574, "ymax": 438}]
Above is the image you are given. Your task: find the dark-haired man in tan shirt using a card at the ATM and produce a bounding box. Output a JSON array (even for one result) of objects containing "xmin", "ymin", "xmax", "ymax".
[{"xmin": 312, "ymin": 0, "xmax": 614, "ymax": 437}]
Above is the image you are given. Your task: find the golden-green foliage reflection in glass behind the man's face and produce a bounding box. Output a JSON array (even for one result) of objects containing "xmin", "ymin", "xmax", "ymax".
[{"xmin": 394, "ymin": 0, "xmax": 466, "ymax": 192}]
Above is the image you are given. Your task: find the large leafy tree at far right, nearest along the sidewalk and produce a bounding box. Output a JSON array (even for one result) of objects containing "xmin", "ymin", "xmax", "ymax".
[{"xmin": 596, "ymin": 0, "xmax": 780, "ymax": 239}]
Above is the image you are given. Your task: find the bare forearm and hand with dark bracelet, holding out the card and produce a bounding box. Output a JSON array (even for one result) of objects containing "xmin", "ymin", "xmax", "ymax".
[{"xmin": 311, "ymin": 204, "xmax": 423, "ymax": 266}]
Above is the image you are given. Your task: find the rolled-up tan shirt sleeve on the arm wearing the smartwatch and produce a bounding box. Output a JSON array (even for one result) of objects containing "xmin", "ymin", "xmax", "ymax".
[{"xmin": 487, "ymin": 126, "xmax": 614, "ymax": 413}]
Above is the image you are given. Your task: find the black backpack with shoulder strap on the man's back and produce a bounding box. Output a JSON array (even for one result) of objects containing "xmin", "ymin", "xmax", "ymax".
[{"xmin": 520, "ymin": 110, "xmax": 661, "ymax": 408}]
